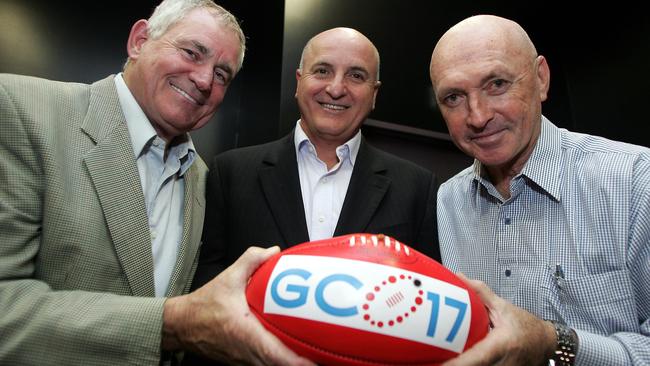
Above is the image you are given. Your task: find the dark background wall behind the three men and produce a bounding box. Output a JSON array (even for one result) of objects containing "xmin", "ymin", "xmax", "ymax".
[{"xmin": 0, "ymin": 0, "xmax": 650, "ymax": 183}]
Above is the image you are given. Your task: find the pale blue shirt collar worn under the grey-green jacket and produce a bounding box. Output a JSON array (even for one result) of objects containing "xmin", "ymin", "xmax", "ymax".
[{"xmin": 115, "ymin": 73, "xmax": 196, "ymax": 175}]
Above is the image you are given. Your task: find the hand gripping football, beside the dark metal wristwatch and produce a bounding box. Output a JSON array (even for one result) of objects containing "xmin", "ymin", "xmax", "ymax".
[{"xmin": 443, "ymin": 274, "xmax": 556, "ymax": 366}]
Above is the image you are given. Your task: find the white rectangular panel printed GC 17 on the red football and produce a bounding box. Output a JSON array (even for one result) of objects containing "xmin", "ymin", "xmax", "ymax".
[{"xmin": 264, "ymin": 255, "xmax": 471, "ymax": 353}]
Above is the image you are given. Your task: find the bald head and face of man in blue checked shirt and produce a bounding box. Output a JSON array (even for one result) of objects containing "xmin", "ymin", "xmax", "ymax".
[{"xmin": 430, "ymin": 16, "xmax": 549, "ymax": 177}]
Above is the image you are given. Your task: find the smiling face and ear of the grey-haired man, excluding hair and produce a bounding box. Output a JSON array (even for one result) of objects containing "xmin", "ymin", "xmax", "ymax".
[{"xmin": 124, "ymin": 8, "xmax": 240, "ymax": 141}]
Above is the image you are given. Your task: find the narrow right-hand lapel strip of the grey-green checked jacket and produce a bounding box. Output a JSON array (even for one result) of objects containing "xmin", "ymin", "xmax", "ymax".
[{"xmin": 167, "ymin": 162, "xmax": 207, "ymax": 296}]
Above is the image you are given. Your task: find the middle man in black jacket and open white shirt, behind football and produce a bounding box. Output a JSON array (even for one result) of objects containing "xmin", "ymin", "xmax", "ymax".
[{"xmin": 193, "ymin": 28, "xmax": 439, "ymax": 286}]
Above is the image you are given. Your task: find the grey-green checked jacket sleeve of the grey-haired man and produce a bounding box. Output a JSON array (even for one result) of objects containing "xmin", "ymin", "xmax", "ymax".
[{"xmin": 0, "ymin": 79, "xmax": 164, "ymax": 365}]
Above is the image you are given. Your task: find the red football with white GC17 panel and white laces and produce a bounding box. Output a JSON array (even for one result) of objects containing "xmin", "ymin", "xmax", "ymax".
[{"xmin": 246, "ymin": 234, "xmax": 489, "ymax": 365}]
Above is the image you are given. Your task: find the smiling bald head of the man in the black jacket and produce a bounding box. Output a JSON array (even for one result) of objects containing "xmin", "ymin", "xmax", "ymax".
[{"xmin": 296, "ymin": 28, "xmax": 380, "ymax": 146}]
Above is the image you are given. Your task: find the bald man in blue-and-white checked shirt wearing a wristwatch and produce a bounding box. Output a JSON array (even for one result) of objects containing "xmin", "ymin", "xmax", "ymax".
[{"xmin": 430, "ymin": 15, "xmax": 650, "ymax": 365}]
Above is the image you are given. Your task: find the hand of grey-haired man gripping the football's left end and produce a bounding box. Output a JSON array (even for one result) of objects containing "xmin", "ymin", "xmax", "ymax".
[{"xmin": 163, "ymin": 247, "xmax": 313, "ymax": 365}]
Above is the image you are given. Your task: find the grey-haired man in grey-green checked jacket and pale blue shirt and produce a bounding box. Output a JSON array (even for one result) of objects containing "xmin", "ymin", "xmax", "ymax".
[{"xmin": 0, "ymin": 0, "xmax": 314, "ymax": 365}]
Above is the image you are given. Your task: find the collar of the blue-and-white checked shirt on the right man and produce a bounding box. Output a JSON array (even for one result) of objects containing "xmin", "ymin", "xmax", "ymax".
[{"xmin": 473, "ymin": 116, "xmax": 564, "ymax": 201}]
